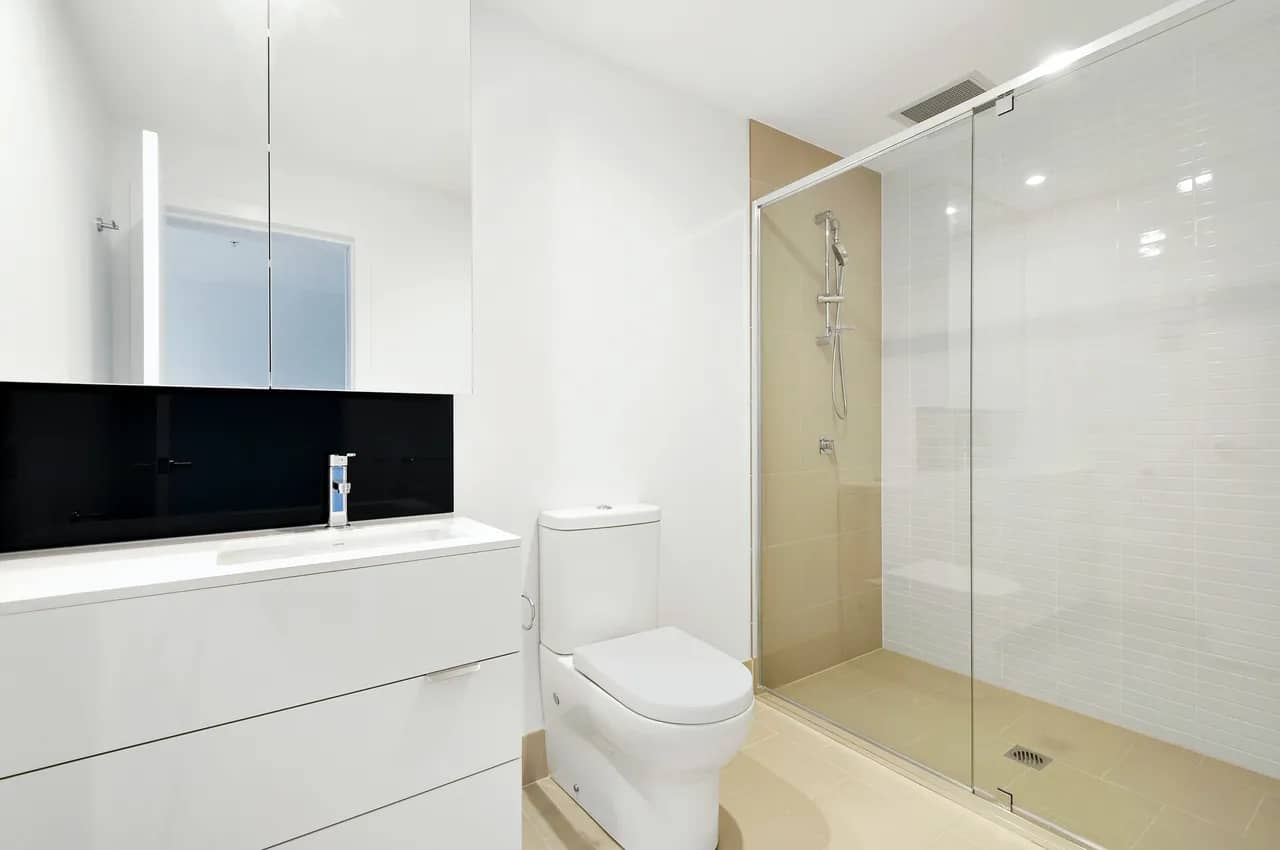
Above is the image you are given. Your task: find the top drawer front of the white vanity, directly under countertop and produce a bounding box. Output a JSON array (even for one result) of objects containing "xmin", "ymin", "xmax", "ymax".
[{"xmin": 0, "ymin": 549, "xmax": 521, "ymax": 777}]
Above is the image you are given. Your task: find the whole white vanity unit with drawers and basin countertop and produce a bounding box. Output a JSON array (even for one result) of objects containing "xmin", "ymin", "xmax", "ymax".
[{"xmin": 0, "ymin": 518, "xmax": 521, "ymax": 850}]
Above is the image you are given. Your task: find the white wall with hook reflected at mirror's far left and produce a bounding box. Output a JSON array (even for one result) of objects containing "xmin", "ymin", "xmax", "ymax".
[{"xmin": 0, "ymin": 0, "xmax": 111, "ymax": 381}]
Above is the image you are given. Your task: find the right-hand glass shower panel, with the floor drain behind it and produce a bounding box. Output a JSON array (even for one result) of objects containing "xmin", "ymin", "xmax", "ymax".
[{"xmin": 973, "ymin": 0, "xmax": 1280, "ymax": 850}]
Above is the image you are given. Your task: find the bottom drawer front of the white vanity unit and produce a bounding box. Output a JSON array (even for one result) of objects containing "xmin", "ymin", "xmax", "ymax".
[{"xmin": 280, "ymin": 762, "xmax": 521, "ymax": 850}]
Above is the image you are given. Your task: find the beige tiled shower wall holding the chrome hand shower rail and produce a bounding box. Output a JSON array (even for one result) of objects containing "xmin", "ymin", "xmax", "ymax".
[{"xmin": 750, "ymin": 122, "xmax": 881, "ymax": 687}]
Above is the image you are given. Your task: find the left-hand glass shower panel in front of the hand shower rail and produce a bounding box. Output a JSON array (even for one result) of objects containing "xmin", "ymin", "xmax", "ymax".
[{"xmin": 758, "ymin": 116, "xmax": 972, "ymax": 786}]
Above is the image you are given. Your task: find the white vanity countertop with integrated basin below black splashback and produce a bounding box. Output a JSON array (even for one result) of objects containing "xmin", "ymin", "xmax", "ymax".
[{"xmin": 0, "ymin": 517, "xmax": 520, "ymax": 616}]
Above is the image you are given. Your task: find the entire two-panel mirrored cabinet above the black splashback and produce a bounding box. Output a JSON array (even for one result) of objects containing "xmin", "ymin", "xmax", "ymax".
[{"xmin": 0, "ymin": 0, "xmax": 471, "ymax": 393}]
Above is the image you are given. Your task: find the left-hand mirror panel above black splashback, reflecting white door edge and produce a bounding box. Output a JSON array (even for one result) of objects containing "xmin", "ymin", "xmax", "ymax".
[{"xmin": 0, "ymin": 0, "xmax": 270, "ymax": 387}]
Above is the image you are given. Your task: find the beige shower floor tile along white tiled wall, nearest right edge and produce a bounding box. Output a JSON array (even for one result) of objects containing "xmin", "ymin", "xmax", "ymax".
[{"xmin": 1107, "ymin": 736, "xmax": 1280, "ymax": 829}]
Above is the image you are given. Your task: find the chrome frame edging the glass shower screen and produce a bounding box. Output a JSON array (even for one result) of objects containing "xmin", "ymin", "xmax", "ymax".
[{"xmin": 749, "ymin": 0, "xmax": 1234, "ymax": 847}]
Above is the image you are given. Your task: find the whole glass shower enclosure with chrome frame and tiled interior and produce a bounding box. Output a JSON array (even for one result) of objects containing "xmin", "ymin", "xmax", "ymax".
[{"xmin": 753, "ymin": 0, "xmax": 1280, "ymax": 850}]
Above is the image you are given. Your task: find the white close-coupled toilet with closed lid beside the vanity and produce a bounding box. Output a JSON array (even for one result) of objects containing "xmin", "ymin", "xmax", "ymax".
[{"xmin": 539, "ymin": 504, "xmax": 754, "ymax": 850}]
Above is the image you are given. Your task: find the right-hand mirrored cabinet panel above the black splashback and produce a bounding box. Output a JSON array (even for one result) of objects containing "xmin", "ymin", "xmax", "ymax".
[{"xmin": 271, "ymin": 0, "xmax": 471, "ymax": 393}]
